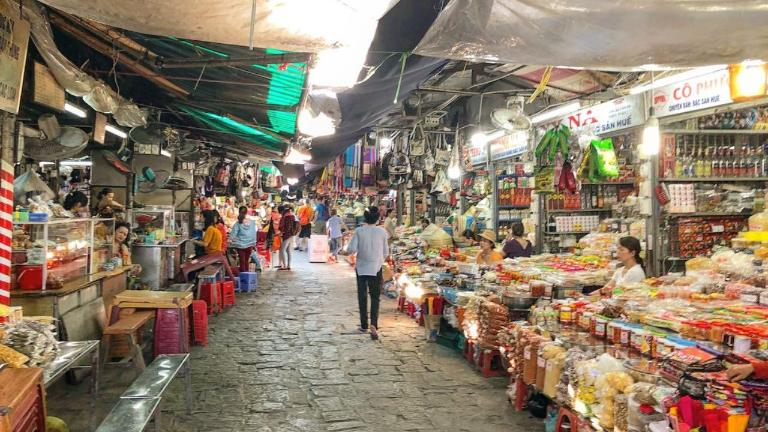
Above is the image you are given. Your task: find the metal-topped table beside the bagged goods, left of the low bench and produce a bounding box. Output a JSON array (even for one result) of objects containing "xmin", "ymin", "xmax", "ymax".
[{"xmin": 43, "ymin": 340, "xmax": 101, "ymax": 430}]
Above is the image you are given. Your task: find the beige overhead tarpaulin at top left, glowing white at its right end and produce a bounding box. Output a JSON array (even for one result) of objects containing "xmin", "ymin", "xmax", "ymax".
[{"xmin": 34, "ymin": 0, "xmax": 398, "ymax": 52}]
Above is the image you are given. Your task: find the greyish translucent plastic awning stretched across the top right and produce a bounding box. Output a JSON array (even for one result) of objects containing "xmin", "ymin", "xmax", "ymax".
[{"xmin": 415, "ymin": 0, "xmax": 768, "ymax": 70}]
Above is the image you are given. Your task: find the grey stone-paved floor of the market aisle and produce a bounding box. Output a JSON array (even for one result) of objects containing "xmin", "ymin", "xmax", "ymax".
[{"xmin": 48, "ymin": 254, "xmax": 543, "ymax": 432}]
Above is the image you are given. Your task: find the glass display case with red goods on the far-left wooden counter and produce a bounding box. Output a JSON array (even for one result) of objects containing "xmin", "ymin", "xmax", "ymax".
[{"xmin": 11, "ymin": 219, "xmax": 92, "ymax": 290}]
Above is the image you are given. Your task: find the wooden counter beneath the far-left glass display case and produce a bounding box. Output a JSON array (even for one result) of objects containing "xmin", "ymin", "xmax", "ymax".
[{"xmin": 11, "ymin": 266, "xmax": 131, "ymax": 340}]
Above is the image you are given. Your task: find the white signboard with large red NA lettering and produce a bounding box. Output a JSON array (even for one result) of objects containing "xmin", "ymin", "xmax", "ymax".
[{"xmin": 560, "ymin": 95, "xmax": 645, "ymax": 135}]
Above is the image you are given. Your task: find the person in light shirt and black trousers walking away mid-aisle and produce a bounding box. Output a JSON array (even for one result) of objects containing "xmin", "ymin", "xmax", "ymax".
[{"xmin": 346, "ymin": 207, "xmax": 389, "ymax": 340}]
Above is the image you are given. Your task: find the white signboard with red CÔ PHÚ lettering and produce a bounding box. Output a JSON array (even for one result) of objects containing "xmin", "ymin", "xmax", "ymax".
[{"xmin": 652, "ymin": 69, "xmax": 732, "ymax": 117}]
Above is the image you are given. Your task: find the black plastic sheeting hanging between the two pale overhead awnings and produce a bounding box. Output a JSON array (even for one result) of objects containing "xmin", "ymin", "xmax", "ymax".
[{"xmin": 307, "ymin": 0, "xmax": 446, "ymax": 170}]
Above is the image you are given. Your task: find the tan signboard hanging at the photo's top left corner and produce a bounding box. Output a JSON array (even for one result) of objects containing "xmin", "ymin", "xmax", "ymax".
[{"xmin": 0, "ymin": 0, "xmax": 29, "ymax": 114}]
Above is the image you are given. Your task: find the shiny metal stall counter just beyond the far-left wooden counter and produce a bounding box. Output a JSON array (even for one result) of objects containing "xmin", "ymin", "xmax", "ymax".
[{"xmin": 131, "ymin": 239, "xmax": 187, "ymax": 290}]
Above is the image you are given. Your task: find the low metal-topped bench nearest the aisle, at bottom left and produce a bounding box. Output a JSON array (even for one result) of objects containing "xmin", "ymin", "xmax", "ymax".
[{"xmin": 96, "ymin": 354, "xmax": 194, "ymax": 432}]
